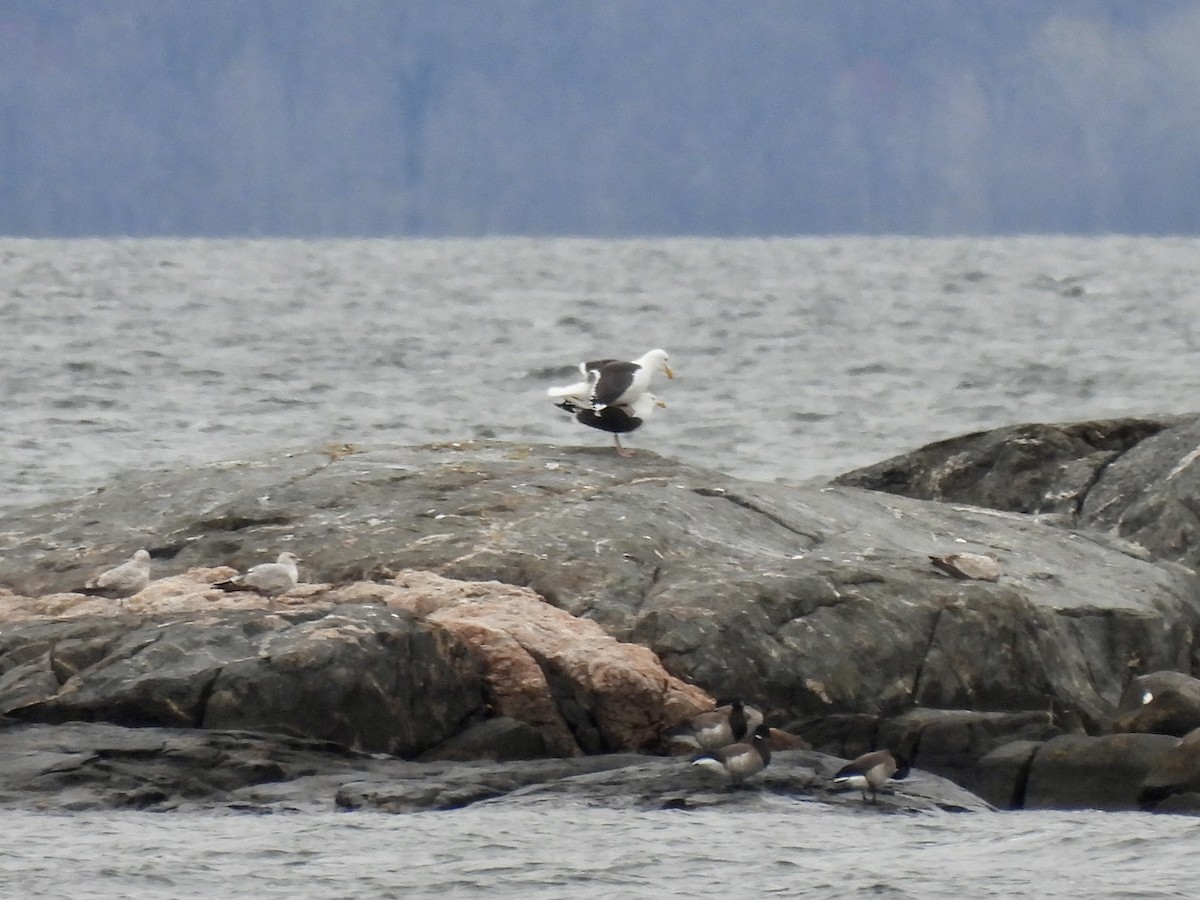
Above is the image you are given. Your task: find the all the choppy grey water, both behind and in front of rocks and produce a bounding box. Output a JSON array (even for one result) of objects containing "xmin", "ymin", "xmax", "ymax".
[{"xmin": 0, "ymin": 238, "xmax": 1200, "ymax": 898}]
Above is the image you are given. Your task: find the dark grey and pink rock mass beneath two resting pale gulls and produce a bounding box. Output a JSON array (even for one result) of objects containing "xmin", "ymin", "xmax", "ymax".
[{"xmin": 0, "ymin": 569, "xmax": 713, "ymax": 758}]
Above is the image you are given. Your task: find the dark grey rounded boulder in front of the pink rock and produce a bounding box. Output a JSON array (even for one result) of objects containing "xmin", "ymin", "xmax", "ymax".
[{"xmin": 0, "ymin": 606, "xmax": 484, "ymax": 756}]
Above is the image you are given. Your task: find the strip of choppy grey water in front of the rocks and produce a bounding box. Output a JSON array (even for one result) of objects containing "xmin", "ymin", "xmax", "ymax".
[{"xmin": 0, "ymin": 802, "xmax": 1200, "ymax": 900}]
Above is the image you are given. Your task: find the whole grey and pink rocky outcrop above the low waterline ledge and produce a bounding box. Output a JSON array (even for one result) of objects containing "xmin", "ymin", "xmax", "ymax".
[{"xmin": 0, "ymin": 427, "xmax": 1200, "ymax": 811}]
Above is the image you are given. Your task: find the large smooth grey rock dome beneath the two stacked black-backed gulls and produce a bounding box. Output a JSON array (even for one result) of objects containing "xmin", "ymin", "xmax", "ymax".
[{"xmin": 0, "ymin": 436, "xmax": 1200, "ymax": 750}]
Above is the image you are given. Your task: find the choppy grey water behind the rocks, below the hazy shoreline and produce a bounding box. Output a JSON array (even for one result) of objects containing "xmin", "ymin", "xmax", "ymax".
[{"xmin": 0, "ymin": 238, "xmax": 1200, "ymax": 510}]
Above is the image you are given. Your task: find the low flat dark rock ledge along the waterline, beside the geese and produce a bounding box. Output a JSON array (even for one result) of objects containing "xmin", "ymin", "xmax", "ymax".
[{"xmin": 0, "ymin": 720, "xmax": 990, "ymax": 814}]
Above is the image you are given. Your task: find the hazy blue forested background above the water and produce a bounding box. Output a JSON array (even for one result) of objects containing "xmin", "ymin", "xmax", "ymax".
[{"xmin": 0, "ymin": 0, "xmax": 1200, "ymax": 236}]
